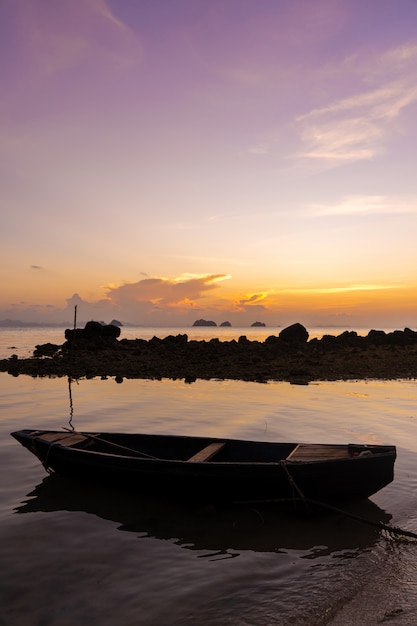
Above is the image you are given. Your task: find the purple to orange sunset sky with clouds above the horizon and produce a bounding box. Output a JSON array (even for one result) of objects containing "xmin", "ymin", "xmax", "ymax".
[{"xmin": 0, "ymin": 0, "xmax": 417, "ymax": 328}]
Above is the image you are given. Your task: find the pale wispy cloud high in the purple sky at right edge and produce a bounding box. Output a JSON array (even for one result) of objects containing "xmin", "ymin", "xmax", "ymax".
[{"xmin": 295, "ymin": 40, "xmax": 417, "ymax": 166}]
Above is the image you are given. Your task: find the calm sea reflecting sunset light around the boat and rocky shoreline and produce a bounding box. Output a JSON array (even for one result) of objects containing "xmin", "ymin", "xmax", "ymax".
[{"xmin": 0, "ymin": 327, "xmax": 417, "ymax": 626}]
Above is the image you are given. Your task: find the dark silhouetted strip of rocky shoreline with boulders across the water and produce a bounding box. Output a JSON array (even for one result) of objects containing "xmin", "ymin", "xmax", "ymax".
[{"xmin": 0, "ymin": 322, "xmax": 417, "ymax": 384}]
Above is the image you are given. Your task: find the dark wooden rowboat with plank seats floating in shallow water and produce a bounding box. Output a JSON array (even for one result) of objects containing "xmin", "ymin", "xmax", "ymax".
[{"xmin": 12, "ymin": 430, "xmax": 396, "ymax": 502}]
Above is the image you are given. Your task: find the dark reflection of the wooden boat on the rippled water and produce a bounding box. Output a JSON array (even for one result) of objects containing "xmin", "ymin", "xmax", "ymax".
[{"xmin": 15, "ymin": 474, "xmax": 391, "ymax": 558}]
